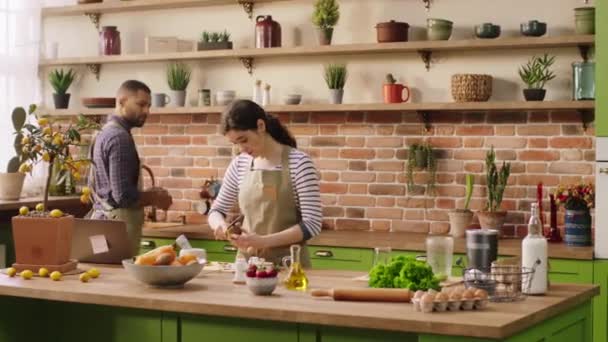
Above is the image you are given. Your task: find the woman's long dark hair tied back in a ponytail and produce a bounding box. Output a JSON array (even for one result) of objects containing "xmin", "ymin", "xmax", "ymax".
[{"xmin": 221, "ymin": 100, "xmax": 297, "ymax": 148}]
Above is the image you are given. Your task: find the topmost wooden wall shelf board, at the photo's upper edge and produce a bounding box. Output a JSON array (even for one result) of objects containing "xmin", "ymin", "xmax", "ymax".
[{"xmin": 42, "ymin": 0, "xmax": 288, "ymax": 17}]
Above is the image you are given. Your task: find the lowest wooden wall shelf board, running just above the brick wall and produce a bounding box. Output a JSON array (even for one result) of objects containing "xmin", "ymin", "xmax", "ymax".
[{"xmin": 41, "ymin": 101, "xmax": 595, "ymax": 116}]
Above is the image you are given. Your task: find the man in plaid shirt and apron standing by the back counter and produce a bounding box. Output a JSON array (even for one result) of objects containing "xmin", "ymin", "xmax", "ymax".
[{"xmin": 89, "ymin": 80, "xmax": 172, "ymax": 254}]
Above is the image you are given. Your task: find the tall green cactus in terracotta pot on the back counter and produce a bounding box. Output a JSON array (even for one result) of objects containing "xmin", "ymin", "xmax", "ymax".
[{"xmin": 477, "ymin": 147, "xmax": 511, "ymax": 231}]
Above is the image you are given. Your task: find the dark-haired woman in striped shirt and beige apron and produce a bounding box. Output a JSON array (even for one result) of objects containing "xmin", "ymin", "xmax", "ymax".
[{"xmin": 208, "ymin": 100, "xmax": 322, "ymax": 267}]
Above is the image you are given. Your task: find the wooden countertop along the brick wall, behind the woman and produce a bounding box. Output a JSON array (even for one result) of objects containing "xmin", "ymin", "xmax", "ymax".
[{"xmin": 143, "ymin": 224, "xmax": 593, "ymax": 260}]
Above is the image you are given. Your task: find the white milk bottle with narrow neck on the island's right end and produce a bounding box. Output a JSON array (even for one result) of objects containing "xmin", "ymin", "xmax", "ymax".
[{"xmin": 521, "ymin": 203, "xmax": 548, "ymax": 295}]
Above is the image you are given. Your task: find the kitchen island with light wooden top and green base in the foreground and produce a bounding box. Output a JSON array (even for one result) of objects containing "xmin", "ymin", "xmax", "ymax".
[{"xmin": 0, "ymin": 265, "xmax": 599, "ymax": 342}]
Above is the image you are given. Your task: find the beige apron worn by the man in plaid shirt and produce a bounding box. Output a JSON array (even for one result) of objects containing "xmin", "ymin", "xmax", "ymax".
[{"xmin": 86, "ymin": 121, "xmax": 144, "ymax": 255}]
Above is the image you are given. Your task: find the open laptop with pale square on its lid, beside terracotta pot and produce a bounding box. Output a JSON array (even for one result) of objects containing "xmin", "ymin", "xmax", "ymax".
[{"xmin": 71, "ymin": 219, "xmax": 133, "ymax": 264}]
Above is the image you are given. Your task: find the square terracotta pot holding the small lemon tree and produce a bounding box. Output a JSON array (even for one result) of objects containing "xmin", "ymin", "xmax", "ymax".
[{"xmin": 12, "ymin": 215, "xmax": 74, "ymax": 272}]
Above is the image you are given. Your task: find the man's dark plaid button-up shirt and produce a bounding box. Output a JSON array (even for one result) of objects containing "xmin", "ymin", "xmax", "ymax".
[{"xmin": 89, "ymin": 115, "xmax": 139, "ymax": 209}]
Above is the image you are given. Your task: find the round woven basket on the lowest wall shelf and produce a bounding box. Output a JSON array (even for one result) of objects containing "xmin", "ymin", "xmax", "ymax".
[{"xmin": 452, "ymin": 74, "xmax": 492, "ymax": 102}]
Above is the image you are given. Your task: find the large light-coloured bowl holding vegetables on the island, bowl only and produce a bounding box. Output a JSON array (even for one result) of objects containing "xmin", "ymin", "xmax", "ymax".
[{"xmin": 122, "ymin": 259, "xmax": 204, "ymax": 287}]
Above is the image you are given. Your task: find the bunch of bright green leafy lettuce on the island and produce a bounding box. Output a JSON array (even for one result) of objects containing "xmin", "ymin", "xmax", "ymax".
[{"xmin": 369, "ymin": 256, "xmax": 440, "ymax": 291}]
